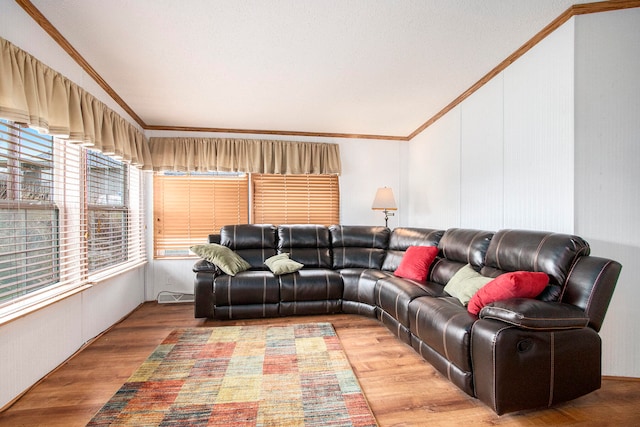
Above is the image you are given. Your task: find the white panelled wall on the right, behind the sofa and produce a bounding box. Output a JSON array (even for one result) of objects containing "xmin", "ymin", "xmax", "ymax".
[{"xmin": 404, "ymin": 9, "xmax": 640, "ymax": 377}]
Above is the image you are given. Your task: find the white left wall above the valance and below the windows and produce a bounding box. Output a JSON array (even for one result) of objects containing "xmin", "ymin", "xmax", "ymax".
[{"xmin": 0, "ymin": 0, "xmax": 145, "ymax": 408}]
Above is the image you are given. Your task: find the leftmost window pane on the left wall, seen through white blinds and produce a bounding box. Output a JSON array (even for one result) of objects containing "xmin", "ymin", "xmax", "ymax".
[{"xmin": 0, "ymin": 122, "xmax": 60, "ymax": 304}]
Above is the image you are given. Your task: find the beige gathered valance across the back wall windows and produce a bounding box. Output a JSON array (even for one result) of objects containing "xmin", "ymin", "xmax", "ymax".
[{"xmin": 149, "ymin": 138, "xmax": 341, "ymax": 174}]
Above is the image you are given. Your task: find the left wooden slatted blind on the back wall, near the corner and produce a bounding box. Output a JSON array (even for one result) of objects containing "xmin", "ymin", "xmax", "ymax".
[{"xmin": 153, "ymin": 173, "xmax": 249, "ymax": 257}]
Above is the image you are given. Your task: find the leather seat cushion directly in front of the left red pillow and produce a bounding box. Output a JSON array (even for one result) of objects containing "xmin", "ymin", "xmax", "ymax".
[{"xmin": 375, "ymin": 276, "xmax": 444, "ymax": 327}]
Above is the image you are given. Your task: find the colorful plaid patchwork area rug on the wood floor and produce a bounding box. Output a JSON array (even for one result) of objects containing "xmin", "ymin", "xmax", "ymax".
[{"xmin": 87, "ymin": 323, "xmax": 377, "ymax": 427}]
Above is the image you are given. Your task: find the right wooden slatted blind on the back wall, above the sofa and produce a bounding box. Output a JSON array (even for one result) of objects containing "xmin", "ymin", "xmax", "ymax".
[{"xmin": 251, "ymin": 174, "xmax": 340, "ymax": 225}]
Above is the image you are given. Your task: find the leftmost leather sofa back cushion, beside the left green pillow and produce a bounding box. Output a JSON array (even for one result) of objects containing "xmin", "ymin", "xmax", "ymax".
[{"xmin": 220, "ymin": 224, "xmax": 276, "ymax": 269}]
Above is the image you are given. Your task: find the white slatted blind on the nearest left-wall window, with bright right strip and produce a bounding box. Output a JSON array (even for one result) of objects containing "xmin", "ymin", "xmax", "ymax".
[{"xmin": 0, "ymin": 122, "xmax": 84, "ymax": 306}]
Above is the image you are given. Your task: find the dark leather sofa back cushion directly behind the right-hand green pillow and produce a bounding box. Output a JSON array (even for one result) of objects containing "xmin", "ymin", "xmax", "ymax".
[{"xmin": 429, "ymin": 228, "xmax": 493, "ymax": 285}]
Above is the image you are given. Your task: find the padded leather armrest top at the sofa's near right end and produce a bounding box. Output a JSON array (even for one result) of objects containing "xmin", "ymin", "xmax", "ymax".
[{"xmin": 479, "ymin": 298, "xmax": 589, "ymax": 331}]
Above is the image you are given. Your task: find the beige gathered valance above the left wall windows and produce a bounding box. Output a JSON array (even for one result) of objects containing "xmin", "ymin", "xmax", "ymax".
[{"xmin": 0, "ymin": 38, "xmax": 151, "ymax": 170}]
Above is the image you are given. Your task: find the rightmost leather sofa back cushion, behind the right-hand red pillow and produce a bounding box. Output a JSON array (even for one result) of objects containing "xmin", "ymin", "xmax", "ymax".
[{"xmin": 481, "ymin": 230, "xmax": 590, "ymax": 286}]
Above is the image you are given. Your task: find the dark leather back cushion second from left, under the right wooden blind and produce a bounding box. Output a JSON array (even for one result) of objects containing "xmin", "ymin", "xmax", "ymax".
[{"xmin": 277, "ymin": 224, "xmax": 332, "ymax": 268}]
